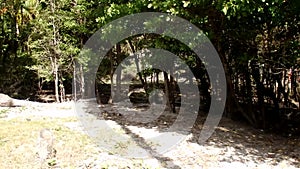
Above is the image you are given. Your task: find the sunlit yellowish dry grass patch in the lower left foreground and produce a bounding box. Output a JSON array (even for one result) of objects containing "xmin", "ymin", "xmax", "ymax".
[{"xmin": 0, "ymin": 118, "xmax": 99, "ymax": 168}]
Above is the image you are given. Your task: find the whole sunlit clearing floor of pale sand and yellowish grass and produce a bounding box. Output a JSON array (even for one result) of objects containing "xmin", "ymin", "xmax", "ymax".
[{"xmin": 0, "ymin": 102, "xmax": 300, "ymax": 169}]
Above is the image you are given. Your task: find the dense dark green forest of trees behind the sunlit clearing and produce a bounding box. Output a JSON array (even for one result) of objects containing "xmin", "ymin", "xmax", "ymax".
[{"xmin": 0, "ymin": 0, "xmax": 300, "ymax": 135}]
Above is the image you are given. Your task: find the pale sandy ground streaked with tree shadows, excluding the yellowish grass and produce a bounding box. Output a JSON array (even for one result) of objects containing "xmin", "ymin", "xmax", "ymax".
[{"xmin": 1, "ymin": 99, "xmax": 300, "ymax": 169}]
